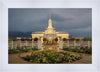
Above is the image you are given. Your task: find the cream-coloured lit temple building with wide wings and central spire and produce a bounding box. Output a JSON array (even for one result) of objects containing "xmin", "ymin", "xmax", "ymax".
[{"xmin": 32, "ymin": 13, "xmax": 69, "ymax": 42}]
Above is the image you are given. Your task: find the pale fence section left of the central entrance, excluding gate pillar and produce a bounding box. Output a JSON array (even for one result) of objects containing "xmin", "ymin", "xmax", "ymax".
[{"xmin": 8, "ymin": 41, "xmax": 38, "ymax": 49}]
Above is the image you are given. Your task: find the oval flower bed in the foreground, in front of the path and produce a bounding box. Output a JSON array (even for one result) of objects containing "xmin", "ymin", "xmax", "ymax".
[{"xmin": 24, "ymin": 51, "xmax": 81, "ymax": 64}]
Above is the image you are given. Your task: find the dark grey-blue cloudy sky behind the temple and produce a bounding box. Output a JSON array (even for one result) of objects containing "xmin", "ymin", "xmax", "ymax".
[{"xmin": 8, "ymin": 8, "xmax": 92, "ymax": 37}]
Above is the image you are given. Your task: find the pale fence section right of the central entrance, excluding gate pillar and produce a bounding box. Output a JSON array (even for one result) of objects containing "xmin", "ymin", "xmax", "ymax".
[{"xmin": 63, "ymin": 40, "xmax": 92, "ymax": 48}]
